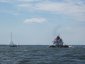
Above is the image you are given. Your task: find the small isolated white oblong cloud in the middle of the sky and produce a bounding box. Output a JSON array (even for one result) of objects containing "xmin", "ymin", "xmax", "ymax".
[{"xmin": 24, "ymin": 17, "xmax": 47, "ymax": 24}]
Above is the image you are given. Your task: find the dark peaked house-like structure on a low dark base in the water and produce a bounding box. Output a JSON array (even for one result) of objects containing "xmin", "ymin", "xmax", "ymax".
[{"xmin": 49, "ymin": 35, "xmax": 69, "ymax": 48}]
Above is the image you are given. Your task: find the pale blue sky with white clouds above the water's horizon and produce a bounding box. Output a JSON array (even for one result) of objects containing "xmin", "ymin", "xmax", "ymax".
[{"xmin": 0, "ymin": 0, "xmax": 85, "ymax": 45}]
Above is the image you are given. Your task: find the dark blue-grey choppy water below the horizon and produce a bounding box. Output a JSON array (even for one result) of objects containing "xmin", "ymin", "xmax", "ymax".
[{"xmin": 0, "ymin": 45, "xmax": 85, "ymax": 64}]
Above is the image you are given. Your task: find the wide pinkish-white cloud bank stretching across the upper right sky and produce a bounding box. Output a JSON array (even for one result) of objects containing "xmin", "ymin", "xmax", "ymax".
[{"xmin": 19, "ymin": 0, "xmax": 85, "ymax": 21}]
